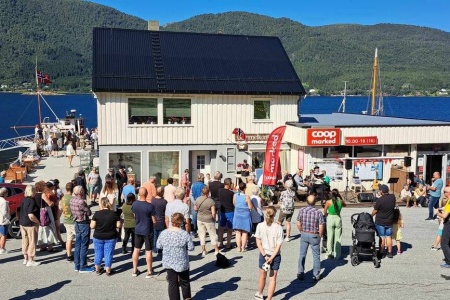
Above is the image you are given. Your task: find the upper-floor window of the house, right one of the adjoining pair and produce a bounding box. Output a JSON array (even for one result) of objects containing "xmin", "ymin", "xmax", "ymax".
[{"xmin": 163, "ymin": 98, "xmax": 191, "ymax": 124}]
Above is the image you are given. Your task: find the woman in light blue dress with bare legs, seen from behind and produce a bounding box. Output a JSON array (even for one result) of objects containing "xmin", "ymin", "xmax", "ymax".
[{"xmin": 233, "ymin": 182, "xmax": 253, "ymax": 252}]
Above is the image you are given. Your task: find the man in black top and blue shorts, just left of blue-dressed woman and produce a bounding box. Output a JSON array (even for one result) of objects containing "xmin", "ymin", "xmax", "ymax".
[{"xmin": 219, "ymin": 178, "xmax": 234, "ymax": 249}]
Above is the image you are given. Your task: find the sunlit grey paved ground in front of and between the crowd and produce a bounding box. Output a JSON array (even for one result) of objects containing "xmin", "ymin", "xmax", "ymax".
[{"xmin": 0, "ymin": 204, "xmax": 450, "ymax": 299}]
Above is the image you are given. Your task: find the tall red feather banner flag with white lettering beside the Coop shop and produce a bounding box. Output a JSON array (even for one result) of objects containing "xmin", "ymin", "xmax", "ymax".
[{"xmin": 263, "ymin": 126, "xmax": 286, "ymax": 185}]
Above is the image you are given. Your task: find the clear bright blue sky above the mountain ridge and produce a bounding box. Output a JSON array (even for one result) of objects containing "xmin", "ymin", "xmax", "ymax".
[{"xmin": 90, "ymin": 0, "xmax": 450, "ymax": 32}]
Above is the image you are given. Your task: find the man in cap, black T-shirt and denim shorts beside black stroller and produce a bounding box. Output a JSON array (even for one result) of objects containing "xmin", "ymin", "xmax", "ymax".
[{"xmin": 372, "ymin": 184, "xmax": 396, "ymax": 258}]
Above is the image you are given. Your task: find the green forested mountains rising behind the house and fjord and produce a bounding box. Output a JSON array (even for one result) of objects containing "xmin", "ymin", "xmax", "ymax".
[{"xmin": 0, "ymin": 0, "xmax": 450, "ymax": 94}]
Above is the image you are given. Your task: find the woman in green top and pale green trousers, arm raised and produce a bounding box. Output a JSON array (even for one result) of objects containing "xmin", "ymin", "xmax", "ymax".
[{"xmin": 323, "ymin": 189, "xmax": 347, "ymax": 259}]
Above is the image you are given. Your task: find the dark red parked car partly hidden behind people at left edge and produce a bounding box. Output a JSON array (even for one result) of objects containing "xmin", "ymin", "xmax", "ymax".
[{"xmin": 0, "ymin": 183, "xmax": 26, "ymax": 239}]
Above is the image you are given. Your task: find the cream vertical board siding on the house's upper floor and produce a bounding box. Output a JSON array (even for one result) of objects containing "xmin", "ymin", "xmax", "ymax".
[{"xmin": 97, "ymin": 93, "xmax": 298, "ymax": 146}]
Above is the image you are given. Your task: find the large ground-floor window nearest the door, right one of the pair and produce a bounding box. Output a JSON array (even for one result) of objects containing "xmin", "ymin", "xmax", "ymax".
[{"xmin": 148, "ymin": 151, "xmax": 180, "ymax": 186}]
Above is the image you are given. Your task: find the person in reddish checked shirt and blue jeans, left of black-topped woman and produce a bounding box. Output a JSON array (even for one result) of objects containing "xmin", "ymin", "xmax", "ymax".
[{"xmin": 70, "ymin": 185, "xmax": 94, "ymax": 273}]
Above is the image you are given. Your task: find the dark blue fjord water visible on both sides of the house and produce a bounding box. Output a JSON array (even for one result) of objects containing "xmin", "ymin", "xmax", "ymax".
[{"xmin": 0, "ymin": 93, "xmax": 450, "ymax": 140}]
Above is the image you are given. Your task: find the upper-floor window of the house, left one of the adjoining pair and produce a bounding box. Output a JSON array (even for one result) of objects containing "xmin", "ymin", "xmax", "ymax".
[{"xmin": 128, "ymin": 98, "xmax": 158, "ymax": 124}]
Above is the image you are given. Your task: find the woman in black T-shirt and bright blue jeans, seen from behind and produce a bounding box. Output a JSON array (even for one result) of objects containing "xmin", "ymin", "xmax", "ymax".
[{"xmin": 90, "ymin": 197, "xmax": 120, "ymax": 276}]
